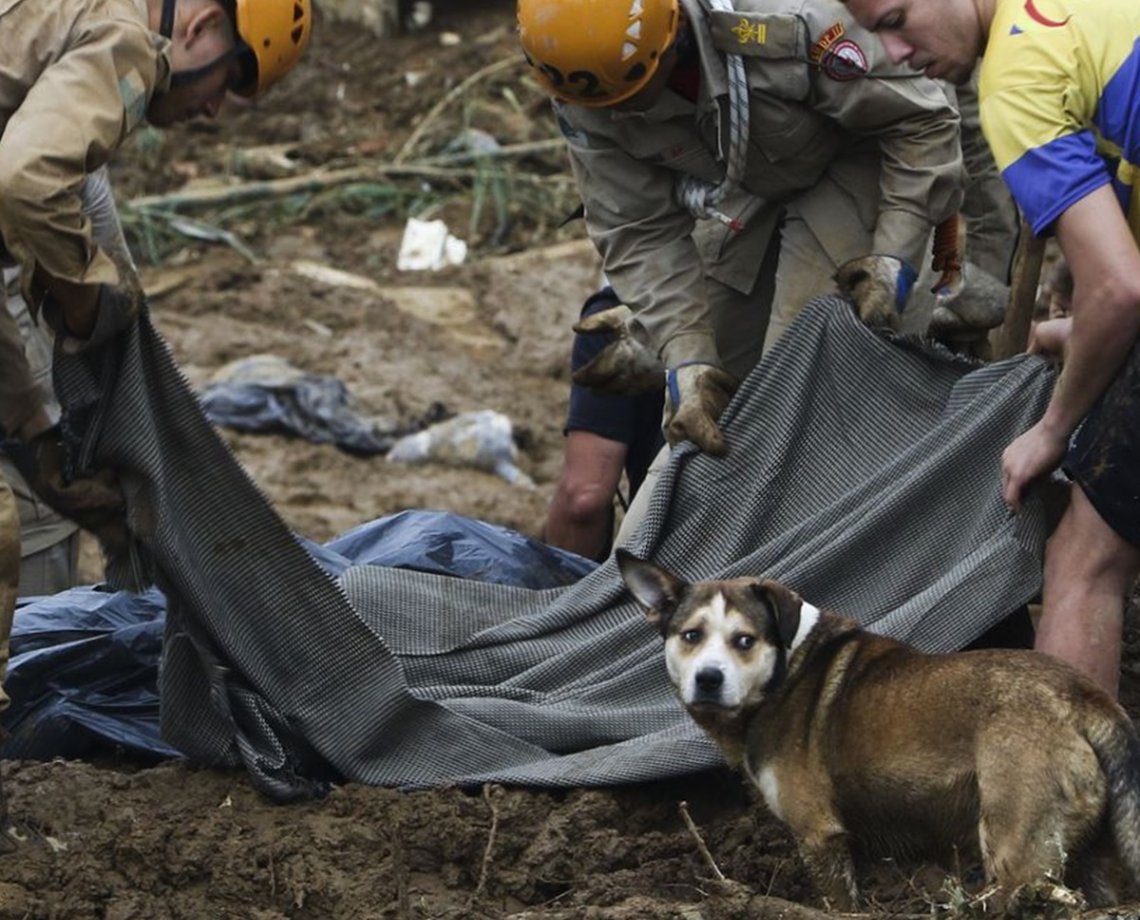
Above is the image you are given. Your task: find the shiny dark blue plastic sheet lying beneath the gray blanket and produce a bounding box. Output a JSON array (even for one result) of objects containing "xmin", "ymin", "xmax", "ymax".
[{"xmin": 0, "ymin": 511, "xmax": 596, "ymax": 760}]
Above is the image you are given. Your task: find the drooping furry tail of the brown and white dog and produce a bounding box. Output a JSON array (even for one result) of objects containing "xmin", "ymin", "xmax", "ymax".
[{"xmin": 1088, "ymin": 710, "xmax": 1140, "ymax": 882}]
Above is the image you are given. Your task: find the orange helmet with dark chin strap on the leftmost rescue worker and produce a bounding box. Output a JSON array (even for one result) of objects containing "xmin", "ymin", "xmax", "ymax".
[{"xmin": 234, "ymin": 0, "xmax": 312, "ymax": 96}]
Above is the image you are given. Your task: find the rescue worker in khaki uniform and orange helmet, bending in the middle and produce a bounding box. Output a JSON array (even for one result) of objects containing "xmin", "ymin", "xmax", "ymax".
[{"xmin": 518, "ymin": 0, "xmax": 964, "ymax": 454}]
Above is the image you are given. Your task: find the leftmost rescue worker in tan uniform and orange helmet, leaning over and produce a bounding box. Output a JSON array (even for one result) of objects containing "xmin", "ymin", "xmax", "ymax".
[{"xmin": 0, "ymin": 0, "xmax": 312, "ymax": 820}]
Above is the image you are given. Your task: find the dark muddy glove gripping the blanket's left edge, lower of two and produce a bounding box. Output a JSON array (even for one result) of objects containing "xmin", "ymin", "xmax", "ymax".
[{"xmin": 3, "ymin": 428, "xmax": 130, "ymax": 557}]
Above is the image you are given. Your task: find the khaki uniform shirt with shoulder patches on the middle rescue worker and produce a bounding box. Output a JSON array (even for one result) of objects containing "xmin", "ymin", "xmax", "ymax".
[{"xmin": 555, "ymin": 0, "xmax": 964, "ymax": 366}]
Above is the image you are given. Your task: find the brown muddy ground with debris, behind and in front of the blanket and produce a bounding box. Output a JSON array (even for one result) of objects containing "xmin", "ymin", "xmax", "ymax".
[{"xmin": 0, "ymin": 0, "xmax": 1140, "ymax": 920}]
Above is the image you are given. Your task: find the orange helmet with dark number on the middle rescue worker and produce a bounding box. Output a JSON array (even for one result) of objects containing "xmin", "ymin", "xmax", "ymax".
[{"xmin": 519, "ymin": 0, "xmax": 681, "ymax": 108}]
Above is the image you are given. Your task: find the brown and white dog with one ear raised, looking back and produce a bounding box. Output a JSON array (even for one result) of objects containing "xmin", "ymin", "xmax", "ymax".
[{"xmin": 617, "ymin": 549, "xmax": 1140, "ymax": 910}]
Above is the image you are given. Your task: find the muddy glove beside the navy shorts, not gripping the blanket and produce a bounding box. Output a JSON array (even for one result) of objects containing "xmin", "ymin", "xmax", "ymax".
[{"xmin": 573, "ymin": 303, "xmax": 665, "ymax": 396}]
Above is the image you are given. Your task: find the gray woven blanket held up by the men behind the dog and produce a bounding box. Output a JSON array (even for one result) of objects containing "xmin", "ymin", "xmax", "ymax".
[{"xmin": 56, "ymin": 298, "xmax": 1052, "ymax": 799}]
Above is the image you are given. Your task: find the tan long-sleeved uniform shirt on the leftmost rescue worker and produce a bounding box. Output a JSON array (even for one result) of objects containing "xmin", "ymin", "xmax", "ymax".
[{"xmin": 0, "ymin": 0, "xmax": 170, "ymax": 432}]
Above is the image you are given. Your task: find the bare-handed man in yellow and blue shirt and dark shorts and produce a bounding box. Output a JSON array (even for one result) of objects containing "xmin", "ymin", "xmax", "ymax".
[{"xmin": 847, "ymin": 0, "xmax": 1140, "ymax": 694}]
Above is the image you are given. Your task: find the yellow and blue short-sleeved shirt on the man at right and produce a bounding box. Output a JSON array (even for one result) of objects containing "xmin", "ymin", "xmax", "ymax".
[{"xmin": 979, "ymin": 0, "xmax": 1140, "ymax": 241}]
